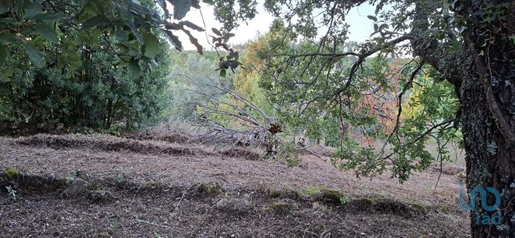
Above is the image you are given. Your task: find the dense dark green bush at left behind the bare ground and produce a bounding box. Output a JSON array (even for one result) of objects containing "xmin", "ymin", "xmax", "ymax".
[{"xmin": 0, "ymin": 1, "xmax": 173, "ymax": 128}]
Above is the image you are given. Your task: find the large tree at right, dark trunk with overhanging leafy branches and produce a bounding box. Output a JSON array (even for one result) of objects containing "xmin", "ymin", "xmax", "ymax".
[{"xmin": 210, "ymin": 0, "xmax": 515, "ymax": 237}]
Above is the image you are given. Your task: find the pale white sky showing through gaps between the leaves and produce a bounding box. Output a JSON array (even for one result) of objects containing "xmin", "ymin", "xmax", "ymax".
[{"xmin": 178, "ymin": 1, "xmax": 375, "ymax": 50}]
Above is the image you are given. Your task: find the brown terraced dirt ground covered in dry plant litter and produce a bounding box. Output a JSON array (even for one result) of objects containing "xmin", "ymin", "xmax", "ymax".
[{"xmin": 0, "ymin": 134, "xmax": 469, "ymax": 237}]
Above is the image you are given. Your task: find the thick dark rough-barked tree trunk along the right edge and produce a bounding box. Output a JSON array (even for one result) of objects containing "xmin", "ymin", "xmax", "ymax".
[{"xmin": 457, "ymin": 0, "xmax": 515, "ymax": 237}]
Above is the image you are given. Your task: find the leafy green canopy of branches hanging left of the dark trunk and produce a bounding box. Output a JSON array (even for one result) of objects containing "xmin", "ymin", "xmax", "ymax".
[{"xmin": 210, "ymin": 0, "xmax": 463, "ymax": 182}]
